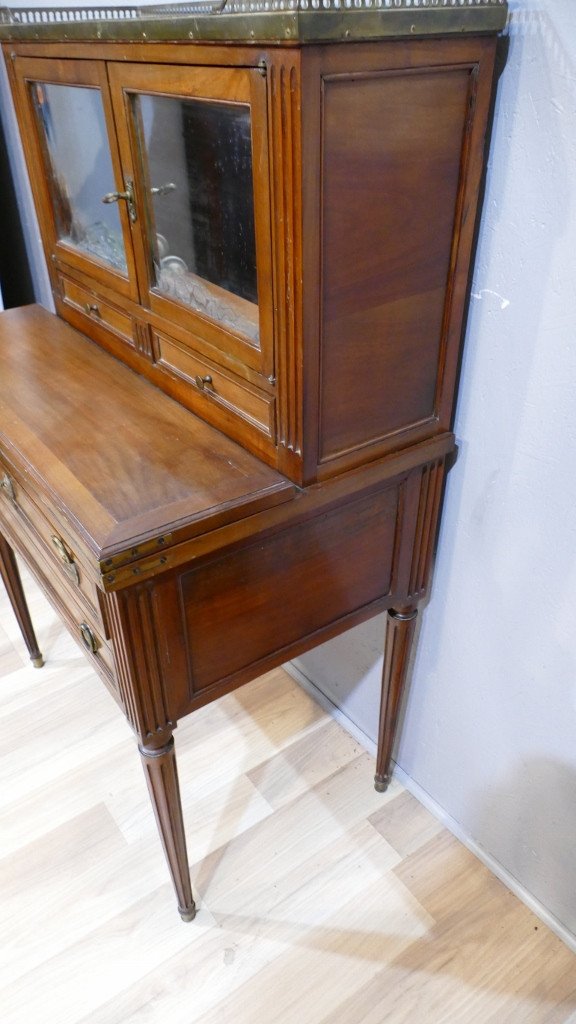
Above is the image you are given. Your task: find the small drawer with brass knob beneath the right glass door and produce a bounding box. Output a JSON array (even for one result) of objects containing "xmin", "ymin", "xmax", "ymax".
[{"xmin": 154, "ymin": 333, "xmax": 275, "ymax": 438}]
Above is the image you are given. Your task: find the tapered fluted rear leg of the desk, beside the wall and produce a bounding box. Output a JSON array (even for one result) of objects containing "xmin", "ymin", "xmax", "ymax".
[{"xmin": 374, "ymin": 607, "xmax": 418, "ymax": 793}]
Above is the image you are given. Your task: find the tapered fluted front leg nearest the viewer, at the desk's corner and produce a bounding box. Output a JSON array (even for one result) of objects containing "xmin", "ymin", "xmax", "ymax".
[{"xmin": 138, "ymin": 737, "xmax": 196, "ymax": 921}]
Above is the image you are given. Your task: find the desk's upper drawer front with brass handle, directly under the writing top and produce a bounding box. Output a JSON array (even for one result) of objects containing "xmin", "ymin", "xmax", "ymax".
[{"xmin": 0, "ymin": 461, "xmax": 99, "ymax": 617}]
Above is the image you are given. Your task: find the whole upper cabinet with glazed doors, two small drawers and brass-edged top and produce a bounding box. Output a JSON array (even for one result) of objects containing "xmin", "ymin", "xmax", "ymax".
[{"xmin": 5, "ymin": 0, "xmax": 505, "ymax": 483}]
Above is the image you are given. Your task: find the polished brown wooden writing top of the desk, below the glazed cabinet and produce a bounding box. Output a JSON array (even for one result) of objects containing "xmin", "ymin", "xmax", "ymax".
[{"xmin": 0, "ymin": 306, "xmax": 296, "ymax": 559}]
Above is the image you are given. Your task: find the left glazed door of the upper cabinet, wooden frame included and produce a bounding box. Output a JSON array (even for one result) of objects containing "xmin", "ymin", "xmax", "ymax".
[{"xmin": 13, "ymin": 57, "xmax": 138, "ymax": 300}]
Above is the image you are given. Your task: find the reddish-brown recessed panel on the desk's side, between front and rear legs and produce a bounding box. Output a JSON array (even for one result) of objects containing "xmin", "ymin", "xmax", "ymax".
[{"xmin": 180, "ymin": 486, "xmax": 398, "ymax": 695}]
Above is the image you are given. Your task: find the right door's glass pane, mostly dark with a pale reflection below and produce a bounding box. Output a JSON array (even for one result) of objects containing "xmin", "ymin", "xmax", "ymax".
[{"xmin": 133, "ymin": 95, "xmax": 258, "ymax": 341}]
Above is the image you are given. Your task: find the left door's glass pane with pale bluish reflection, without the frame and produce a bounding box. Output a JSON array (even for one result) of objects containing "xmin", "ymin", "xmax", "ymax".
[{"xmin": 32, "ymin": 82, "xmax": 126, "ymax": 273}]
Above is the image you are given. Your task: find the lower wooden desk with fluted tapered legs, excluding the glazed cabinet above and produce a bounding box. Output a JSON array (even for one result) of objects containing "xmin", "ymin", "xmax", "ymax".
[{"xmin": 0, "ymin": 306, "xmax": 454, "ymax": 920}]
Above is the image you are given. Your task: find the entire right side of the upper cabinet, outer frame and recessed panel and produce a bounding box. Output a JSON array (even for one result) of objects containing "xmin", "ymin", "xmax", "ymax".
[{"xmin": 295, "ymin": 38, "xmax": 494, "ymax": 480}]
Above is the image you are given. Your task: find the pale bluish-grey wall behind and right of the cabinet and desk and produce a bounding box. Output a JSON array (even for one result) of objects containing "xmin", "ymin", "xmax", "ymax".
[{"xmin": 296, "ymin": 0, "xmax": 576, "ymax": 934}]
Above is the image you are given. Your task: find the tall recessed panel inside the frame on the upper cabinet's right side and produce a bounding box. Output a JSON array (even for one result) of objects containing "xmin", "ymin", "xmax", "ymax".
[{"xmin": 319, "ymin": 65, "xmax": 475, "ymax": 462}]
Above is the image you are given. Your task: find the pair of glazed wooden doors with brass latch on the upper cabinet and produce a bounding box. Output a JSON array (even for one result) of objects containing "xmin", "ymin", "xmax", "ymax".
[{"xmin": 12, "ymin": 58, "xmax": 274, "ymax": 376}]
